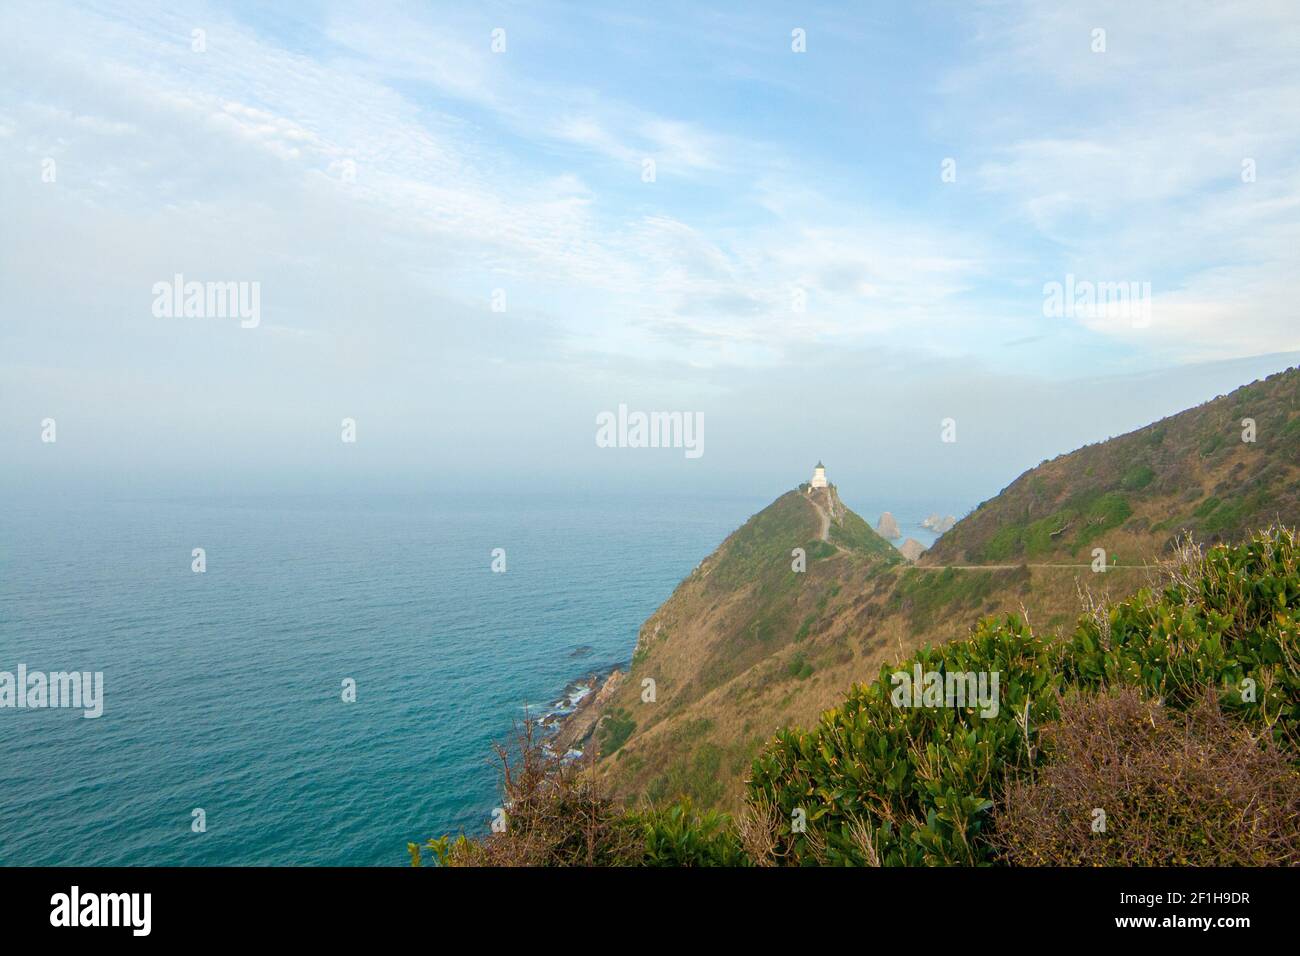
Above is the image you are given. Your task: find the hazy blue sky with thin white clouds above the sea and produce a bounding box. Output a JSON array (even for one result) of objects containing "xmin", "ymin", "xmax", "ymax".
[{"xmin": 0, "ymin": 0, "xmax": 1300, "ymax": 509}]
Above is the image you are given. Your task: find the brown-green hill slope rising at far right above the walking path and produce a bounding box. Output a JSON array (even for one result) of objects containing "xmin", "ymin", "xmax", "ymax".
[{"xmin": 920, "ymin": 369, "xmax": 1300, "ymax": 564}]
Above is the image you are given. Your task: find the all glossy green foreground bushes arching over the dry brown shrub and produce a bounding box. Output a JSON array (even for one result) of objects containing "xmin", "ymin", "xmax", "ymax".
[{"xmin": 749, "ymin": 529, "xmax": 1300, "ymax": 865}]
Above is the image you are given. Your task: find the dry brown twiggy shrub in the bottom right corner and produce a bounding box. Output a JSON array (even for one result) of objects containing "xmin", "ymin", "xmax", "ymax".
[{"xmin": 993, "ymin": 688, "xmax": 1300, "ymax": 866}]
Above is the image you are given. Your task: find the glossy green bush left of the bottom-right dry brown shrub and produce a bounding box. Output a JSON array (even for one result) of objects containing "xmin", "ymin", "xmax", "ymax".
[{"xmin": 749, "ymin": 617, "xmax": 1061, "ymax": 865}]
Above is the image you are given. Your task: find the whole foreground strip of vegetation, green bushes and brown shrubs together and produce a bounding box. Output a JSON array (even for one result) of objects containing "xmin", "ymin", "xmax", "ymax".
[{"xmin": 418, "ymin": 528, "xmax": 1300, "ymax": 866}]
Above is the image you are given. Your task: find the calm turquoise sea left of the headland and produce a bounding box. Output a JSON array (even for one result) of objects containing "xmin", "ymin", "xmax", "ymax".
[{"xmin": 0, "ymin": 496, "xmax": 956, "ymax": 865}]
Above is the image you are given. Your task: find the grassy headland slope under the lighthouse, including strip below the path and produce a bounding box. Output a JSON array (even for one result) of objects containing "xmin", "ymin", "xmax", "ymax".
[{"xmin": 560, "ymin": 489, "xmax": 1147, "ymax": 809}]
